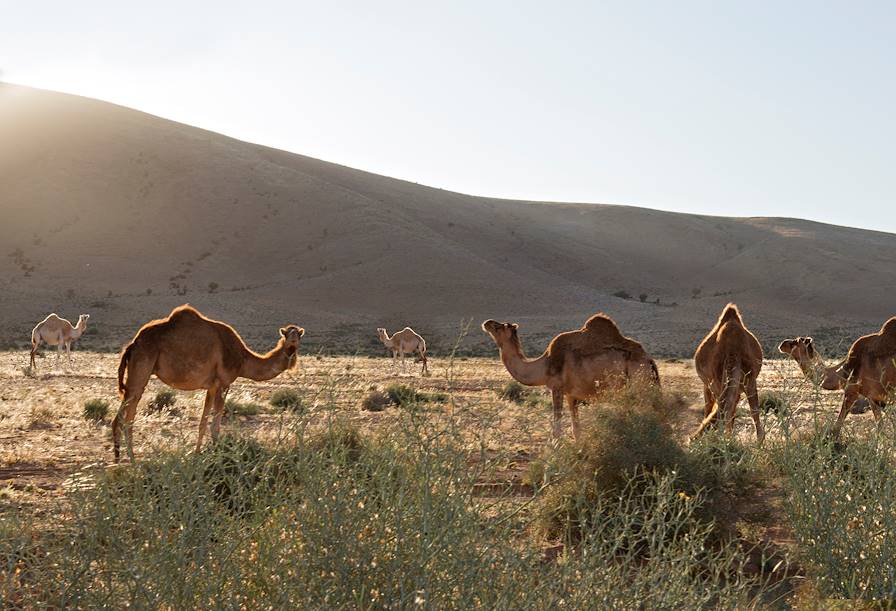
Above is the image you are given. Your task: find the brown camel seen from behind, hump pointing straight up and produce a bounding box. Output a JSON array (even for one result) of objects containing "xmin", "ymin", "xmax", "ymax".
[{"xmin": 694, "ymin": 303, "xmax": 765, "ymax": 443}]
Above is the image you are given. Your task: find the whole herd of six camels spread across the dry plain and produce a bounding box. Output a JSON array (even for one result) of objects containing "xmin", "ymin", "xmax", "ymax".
[{"xmin": 24, "ymin": 304, "xmax": 896, "ymax": 462}]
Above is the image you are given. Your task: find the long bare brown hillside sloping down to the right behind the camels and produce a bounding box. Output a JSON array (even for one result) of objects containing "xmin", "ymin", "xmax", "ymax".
[{"xmin": 0, "ymin": 84, "xmax": 896, "ymax": 354}]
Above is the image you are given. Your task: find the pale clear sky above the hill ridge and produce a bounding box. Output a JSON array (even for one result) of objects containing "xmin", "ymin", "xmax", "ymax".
[{"xmin": 0, "ymin": 0, "xmax": 896, "ymax": 232}]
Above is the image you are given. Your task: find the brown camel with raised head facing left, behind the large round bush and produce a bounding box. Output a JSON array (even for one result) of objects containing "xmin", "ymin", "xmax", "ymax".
[{"xmin": 482, "ymin": 313, "xmax": 659, "ymax": 440}]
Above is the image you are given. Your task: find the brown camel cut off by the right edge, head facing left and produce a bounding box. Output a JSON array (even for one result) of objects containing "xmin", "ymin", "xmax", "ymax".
[{"xmin": 778, "ymin": 316, "xmax": 896, "ymax": 437}]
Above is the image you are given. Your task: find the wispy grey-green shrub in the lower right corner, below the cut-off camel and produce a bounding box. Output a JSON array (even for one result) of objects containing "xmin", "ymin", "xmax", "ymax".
[{"xmin": 776, "ymin": 431, "xmax": 896, "ymax": 601}]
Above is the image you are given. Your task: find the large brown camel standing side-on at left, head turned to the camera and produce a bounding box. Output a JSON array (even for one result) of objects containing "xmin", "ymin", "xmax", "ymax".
[{"xmin": 112, "ymin": 305, "xmax": 305, "ymax": 462}]
